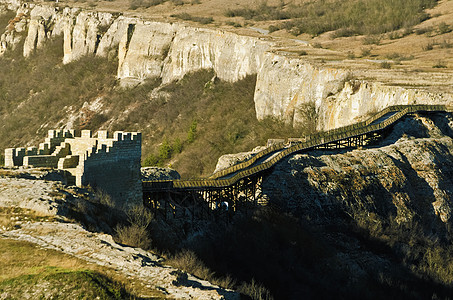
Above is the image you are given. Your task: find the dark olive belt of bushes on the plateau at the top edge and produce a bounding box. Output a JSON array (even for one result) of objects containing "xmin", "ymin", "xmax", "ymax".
[{"xmin": 225, "ymin": 0, "xmax": 436, "ymax": 37}]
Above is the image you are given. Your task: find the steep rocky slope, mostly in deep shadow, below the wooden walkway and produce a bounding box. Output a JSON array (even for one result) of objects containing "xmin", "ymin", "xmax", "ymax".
[{"xmin": 164, "ymin": 113, "xmax": 453, "ymax": 299}]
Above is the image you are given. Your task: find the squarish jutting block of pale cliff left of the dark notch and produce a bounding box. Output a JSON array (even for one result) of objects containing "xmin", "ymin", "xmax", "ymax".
[{"xmin": 255, "ymin": 53, "xmax": 349, "ymax": 126}]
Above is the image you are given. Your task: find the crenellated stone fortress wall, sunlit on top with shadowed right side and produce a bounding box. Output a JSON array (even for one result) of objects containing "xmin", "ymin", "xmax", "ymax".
[{"xmin": 5, "ymin": 130, "xmax": 142, "ymax": 207}]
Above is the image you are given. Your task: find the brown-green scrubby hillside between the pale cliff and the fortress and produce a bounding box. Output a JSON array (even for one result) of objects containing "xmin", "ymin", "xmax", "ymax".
[{"xmin": 0, "ymin": 12, "xmax": 299, "ymax": 177}]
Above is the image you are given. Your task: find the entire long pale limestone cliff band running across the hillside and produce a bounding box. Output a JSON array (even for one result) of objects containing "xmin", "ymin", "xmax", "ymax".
[{"xmin": 0, "ymin": 0, "xmax": 453, "ymax": 130}]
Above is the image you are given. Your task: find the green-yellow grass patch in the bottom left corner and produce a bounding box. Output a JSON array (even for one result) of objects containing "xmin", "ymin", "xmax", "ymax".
[{"xmin": 0, "ymin": 238, "xmax": 165, "ymax": 299}]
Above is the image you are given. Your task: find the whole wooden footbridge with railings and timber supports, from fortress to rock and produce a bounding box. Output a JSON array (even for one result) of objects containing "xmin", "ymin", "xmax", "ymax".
[{"xmin": 143, "ymin": 105, "xmax": 451, "ymax": 219}]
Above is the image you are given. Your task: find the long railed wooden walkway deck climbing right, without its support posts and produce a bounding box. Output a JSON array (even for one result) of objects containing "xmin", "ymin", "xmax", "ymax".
[{"xmin": 143, "ymin": 105, "xmax": 448, "ymax": 190}]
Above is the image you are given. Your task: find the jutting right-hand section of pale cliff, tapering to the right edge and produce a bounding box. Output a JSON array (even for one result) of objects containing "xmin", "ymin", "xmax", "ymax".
[{"xmin": 255, "ymin": 53, "xmax": 453, "ymax": 130}]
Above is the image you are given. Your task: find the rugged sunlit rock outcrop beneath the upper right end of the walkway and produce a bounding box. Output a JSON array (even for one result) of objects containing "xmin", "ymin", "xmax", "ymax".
[{"xmin": 263, "ymin": 114, "xmax": 453, "ymax": 237}]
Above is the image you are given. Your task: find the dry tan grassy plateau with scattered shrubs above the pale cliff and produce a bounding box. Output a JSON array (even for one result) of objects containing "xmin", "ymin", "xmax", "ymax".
[{"xmin": 85, "ymin": 0, "xmax": 453, "ymax": 73}]
